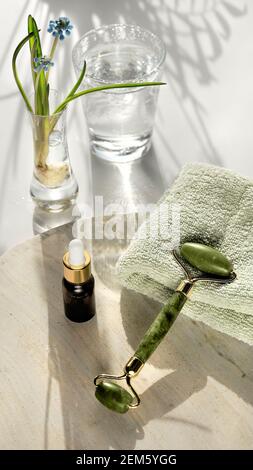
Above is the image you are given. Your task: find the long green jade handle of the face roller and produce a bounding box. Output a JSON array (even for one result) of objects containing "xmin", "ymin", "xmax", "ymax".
[{"xmin": 134, "ymin": 292, "xmax": 187, "ymax": 363}]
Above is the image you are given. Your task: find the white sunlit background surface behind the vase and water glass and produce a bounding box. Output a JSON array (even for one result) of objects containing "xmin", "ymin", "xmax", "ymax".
[{"xmin": 0, "ymin": 0, "xmax": 253, "ymax": 252}]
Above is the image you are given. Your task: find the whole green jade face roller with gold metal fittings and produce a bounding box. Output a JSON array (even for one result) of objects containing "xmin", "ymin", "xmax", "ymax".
[{"xmin": 94, "ymin": 243, "xmax": 236, "ymax": 413}]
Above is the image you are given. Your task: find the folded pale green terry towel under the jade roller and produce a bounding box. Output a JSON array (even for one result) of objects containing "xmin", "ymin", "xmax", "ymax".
[{"xmin": 118, "ymin": 164, "xmax": 253, "ymax": 344}]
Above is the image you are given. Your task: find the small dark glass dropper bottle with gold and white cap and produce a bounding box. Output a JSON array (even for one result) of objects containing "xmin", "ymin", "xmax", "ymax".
[{"xmin": 62, "ymin": 239, "xmax": 96, "ymax": 323}]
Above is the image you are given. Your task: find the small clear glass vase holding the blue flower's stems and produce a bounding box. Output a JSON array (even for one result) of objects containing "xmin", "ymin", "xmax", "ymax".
[{"xmin": 29, "ymin": 90, "xmax": 78, "ymax": 211}]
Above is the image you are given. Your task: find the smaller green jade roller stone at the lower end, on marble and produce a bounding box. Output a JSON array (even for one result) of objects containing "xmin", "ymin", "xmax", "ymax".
[{"xmin": 95, "ymin": 381, "xmax": 133, "ymax": 414}]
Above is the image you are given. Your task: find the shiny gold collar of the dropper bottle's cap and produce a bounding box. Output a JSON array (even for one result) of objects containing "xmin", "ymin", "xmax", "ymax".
[{"xmin": 62, "ymin": 250, "xmax": 91, "ymax": 284}]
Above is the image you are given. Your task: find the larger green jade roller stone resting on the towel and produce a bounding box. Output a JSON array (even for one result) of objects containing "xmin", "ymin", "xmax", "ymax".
[{"xmin": 180, "ymin": 243, "xmax": 233, "ymax": 277}]
